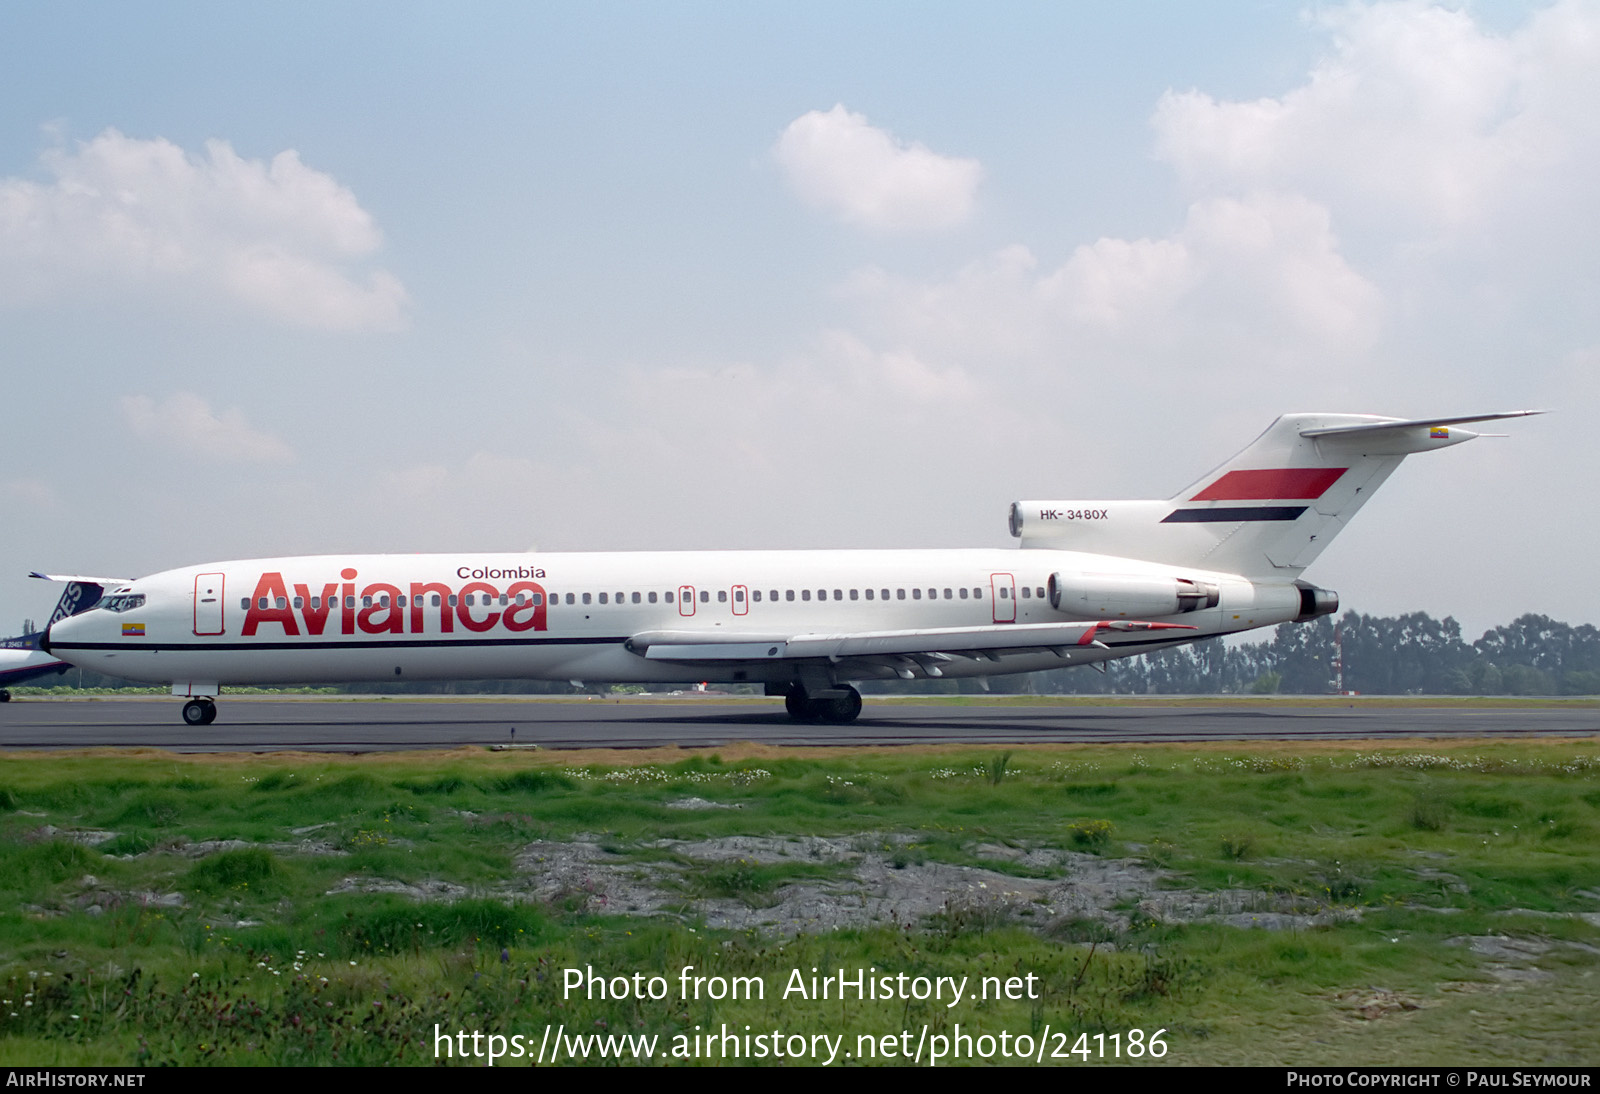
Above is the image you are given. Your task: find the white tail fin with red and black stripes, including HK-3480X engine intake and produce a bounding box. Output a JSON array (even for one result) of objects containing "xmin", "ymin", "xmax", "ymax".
[{"xmin": 1011, "ymin": 411, "xmax": 1541, "ymax": 581}]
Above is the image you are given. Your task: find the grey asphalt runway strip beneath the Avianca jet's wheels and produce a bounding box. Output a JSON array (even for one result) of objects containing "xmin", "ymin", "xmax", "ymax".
[{"xmin": 0, "ymin": 696, "xmax": 1600, "ymax": 752}]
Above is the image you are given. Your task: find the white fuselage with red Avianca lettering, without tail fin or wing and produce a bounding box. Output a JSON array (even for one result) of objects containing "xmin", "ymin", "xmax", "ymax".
[{"xmin": 48, "ymin": 549, "xmax": 1301, "ymax": 694}]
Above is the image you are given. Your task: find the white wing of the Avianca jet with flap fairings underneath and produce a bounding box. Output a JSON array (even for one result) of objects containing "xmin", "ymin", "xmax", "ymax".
[{"xmin": 627, "ymin": 619, "xmax": 1194, "ymax": 678}]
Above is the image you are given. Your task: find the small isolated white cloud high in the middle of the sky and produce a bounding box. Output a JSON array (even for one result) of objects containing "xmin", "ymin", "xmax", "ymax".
[{"xmin": 773, "ymin": 104, "xmax": 982, "ymax": 232}]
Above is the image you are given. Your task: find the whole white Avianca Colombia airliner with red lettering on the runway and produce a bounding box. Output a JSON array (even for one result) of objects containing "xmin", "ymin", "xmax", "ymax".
[{"xmin": 34, "ymin": 411, "xmax": 1541, "ymax": 726}]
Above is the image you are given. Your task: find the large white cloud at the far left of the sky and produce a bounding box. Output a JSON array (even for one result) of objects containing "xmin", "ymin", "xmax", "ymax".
[{"xmin": 0, "ymin": 130, "xmax": 406, "ymax": 331}]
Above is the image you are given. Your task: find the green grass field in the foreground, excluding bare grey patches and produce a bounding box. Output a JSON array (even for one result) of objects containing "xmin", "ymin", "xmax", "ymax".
[{"xmin": 0, "ymin": 742, "xmax": 1600, "ymax": 1065}]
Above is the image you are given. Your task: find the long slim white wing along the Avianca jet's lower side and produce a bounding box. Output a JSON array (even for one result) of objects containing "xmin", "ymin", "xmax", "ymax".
[{"xmin": 627, "ymin": 619, "xmax": 1194, "ymax": 661}]
